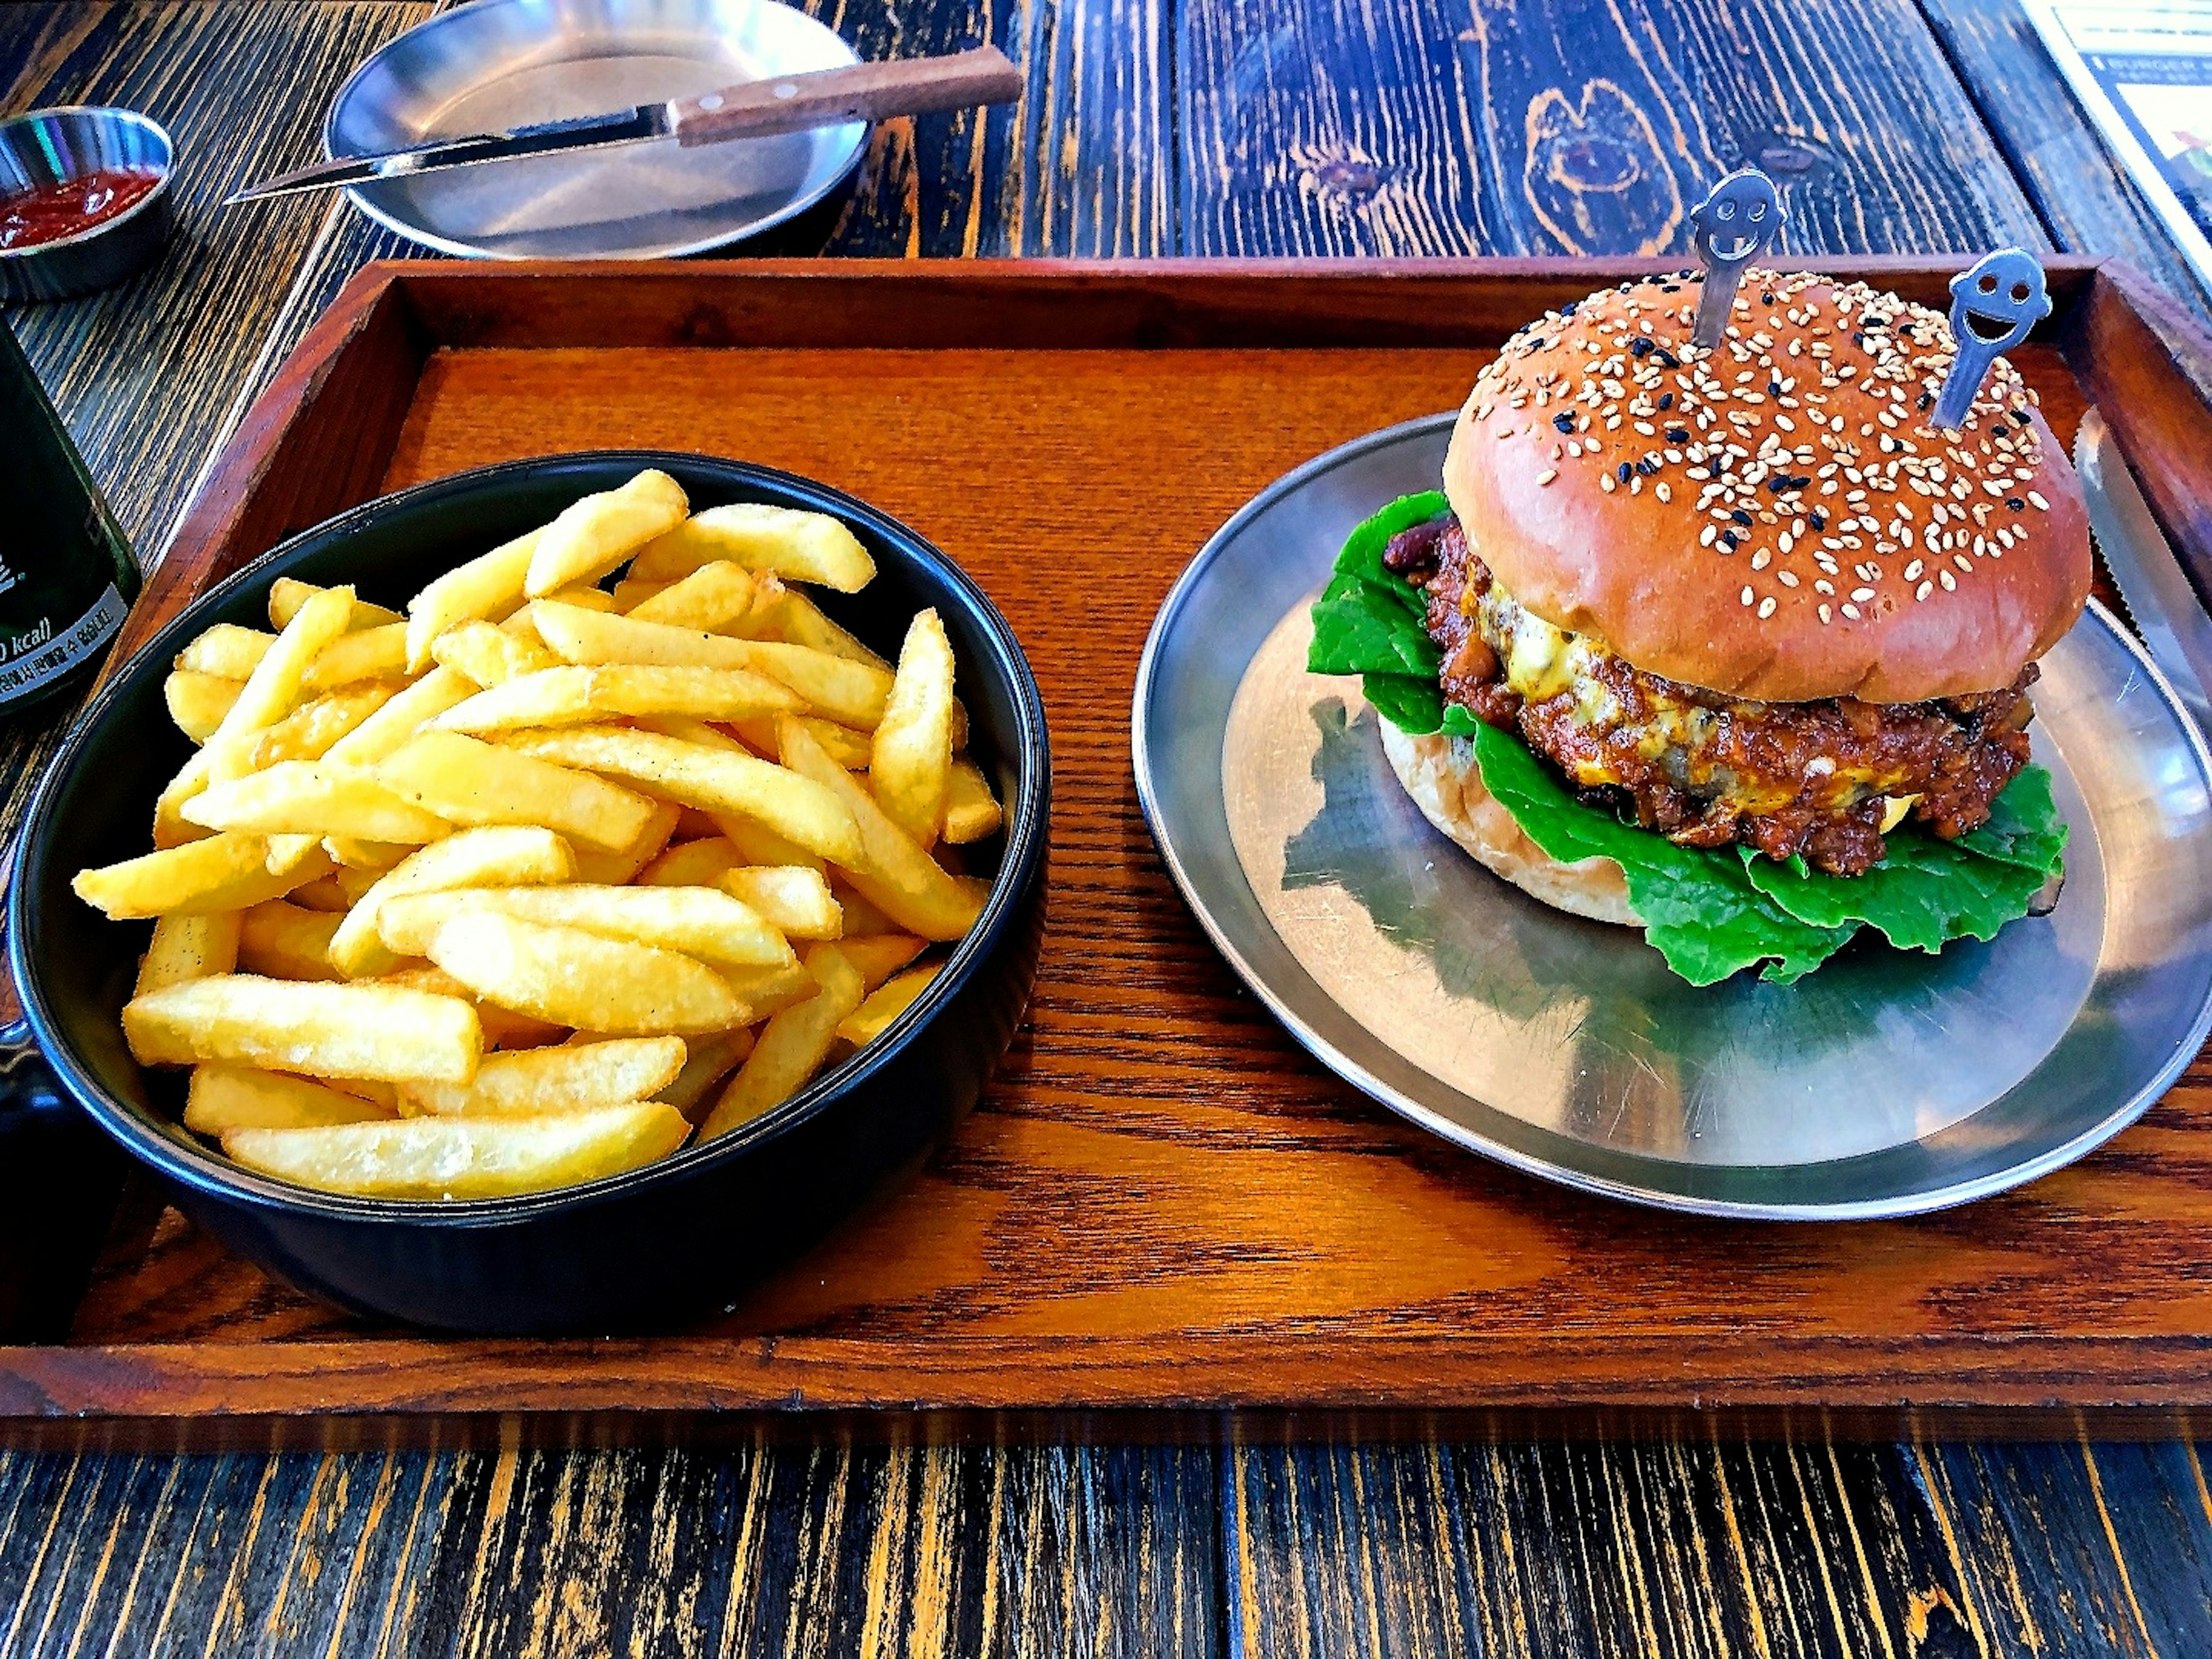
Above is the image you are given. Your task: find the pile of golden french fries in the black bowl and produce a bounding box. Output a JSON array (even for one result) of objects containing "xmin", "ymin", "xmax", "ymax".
[{"xmin": 75, "ymin": 471, "xmax": 1002, "ymax": 1199}]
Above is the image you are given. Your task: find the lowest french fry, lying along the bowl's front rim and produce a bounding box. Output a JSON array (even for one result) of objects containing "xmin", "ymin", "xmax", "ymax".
[{"xmin": 224, "ymin": 1101, "xmax": 690, "ymax": 1199}]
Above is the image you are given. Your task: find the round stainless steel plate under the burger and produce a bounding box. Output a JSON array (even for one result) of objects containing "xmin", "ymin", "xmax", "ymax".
[{"xmin": 1132, "ymin": 416, "xmax": 2212, "ymax": 1219}]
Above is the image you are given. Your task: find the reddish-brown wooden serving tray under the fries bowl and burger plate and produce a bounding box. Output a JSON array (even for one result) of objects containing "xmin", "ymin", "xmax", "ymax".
[{"xmin": 0, "ymin": 259, "xmax": 2212, "ymax": 1446}]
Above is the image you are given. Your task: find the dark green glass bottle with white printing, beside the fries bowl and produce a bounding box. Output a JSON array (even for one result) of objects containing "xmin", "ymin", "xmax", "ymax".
[{"xmin": 0, "ymin": 316, "xmax": 139, "ymax": 717}]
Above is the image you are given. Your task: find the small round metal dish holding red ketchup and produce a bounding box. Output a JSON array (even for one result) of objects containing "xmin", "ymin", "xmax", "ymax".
[{"xmin": 0, "ymin": 104, "xmax": 177, "ymax": 305}]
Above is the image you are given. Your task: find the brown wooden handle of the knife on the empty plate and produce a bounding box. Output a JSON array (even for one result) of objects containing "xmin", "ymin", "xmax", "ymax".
[{"xmin": 675, "ymin": 47, "xmax": 1022, "ymax": 148}]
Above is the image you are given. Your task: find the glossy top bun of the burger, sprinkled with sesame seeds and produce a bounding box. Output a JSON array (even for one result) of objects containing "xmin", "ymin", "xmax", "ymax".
[{"xmin": 1445, "ymin": 270, "xmax": 2090, "ymax": 703}]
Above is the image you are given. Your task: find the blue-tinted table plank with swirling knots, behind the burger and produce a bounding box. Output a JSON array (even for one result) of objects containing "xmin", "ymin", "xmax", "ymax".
[{"xmin": 1177, "ymin": 0, "xmax": 2048, "ymax": 255}]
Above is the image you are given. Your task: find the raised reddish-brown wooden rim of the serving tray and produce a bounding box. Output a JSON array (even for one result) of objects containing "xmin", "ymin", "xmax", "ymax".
[{"xmin": 13, "ymin": 255, "xmax": 2212, "ymax": 1451}]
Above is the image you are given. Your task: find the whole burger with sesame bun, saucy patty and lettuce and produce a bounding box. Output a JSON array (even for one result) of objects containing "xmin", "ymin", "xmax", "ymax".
[{"xmin": 1309, "ymin": 270, "xmax": 2090, "ymax": 982}]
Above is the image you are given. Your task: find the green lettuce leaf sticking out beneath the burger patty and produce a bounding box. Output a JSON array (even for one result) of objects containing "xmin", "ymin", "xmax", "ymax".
[{"xmin": 1307, "ymin": 491, "xmax": 2066, "ymax": 984}]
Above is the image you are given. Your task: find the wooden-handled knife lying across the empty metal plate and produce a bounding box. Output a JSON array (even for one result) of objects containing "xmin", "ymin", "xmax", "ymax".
[{"xmin": 224, "ymin": 47, "xmax": 1022, "ymax": 208}]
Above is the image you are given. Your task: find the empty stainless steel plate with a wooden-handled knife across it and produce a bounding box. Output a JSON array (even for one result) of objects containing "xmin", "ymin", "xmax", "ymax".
[{"xmin": 323, "ymin": 0, "xmax": 867, "ymax": 259}]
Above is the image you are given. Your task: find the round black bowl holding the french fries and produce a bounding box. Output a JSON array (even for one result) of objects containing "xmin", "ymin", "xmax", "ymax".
[{"xmin": 9, "ymin": 451, "xmax": 1051, "ymax": 1334}]
